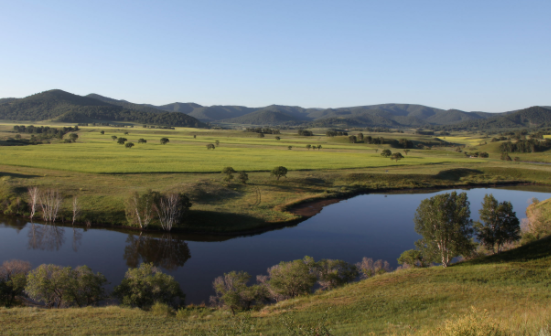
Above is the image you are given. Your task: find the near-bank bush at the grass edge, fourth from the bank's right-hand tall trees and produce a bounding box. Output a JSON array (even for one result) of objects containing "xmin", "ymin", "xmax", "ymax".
[{"xmin": 212, "ymin": 271, "xmax": 268, "ymax": 315}]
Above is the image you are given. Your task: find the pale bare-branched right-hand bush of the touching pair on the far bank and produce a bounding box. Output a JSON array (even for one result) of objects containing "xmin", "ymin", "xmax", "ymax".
[{"xmin": 154, "ymin": 193, "xmax": 191, "ymax": 231}]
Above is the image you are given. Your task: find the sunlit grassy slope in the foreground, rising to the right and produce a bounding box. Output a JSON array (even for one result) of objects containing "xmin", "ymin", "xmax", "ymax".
[{"xmin": 0, "ymin": 238, "xmax": 551, "ymax": 335}]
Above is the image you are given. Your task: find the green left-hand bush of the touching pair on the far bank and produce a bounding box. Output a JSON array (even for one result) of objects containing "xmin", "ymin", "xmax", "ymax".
[{"xmin": 125, "ymin": 190, "xmax": 161, "ymax": 229}]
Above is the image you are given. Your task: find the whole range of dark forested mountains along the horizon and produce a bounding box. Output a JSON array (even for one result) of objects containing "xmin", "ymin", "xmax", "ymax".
[{"xmin": 0, "ymin": 90, "xmax": 551, "ymax": 130}]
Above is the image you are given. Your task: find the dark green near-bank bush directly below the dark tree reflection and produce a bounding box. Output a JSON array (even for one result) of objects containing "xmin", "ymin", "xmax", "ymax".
[{"xmin": 113, "ymin": 263, "xmax": 185, "ymax": 308}]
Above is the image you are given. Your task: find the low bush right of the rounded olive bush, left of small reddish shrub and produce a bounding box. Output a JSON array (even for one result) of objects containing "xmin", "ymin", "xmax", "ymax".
[{"xmin": 304, "ymin": 257, "xmax": 358, "ymax": 289}]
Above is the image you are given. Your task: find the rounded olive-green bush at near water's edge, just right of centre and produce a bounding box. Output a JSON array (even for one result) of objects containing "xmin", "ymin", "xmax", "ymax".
[{"xmin": 268, "ymin": 259, "xmax": 317, "ymax": 297}]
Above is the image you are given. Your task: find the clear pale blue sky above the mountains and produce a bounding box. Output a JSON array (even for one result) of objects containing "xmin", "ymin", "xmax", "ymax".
[{"xmin": 0, "ymin": 0, "xmax": 551, "ymax": 112}]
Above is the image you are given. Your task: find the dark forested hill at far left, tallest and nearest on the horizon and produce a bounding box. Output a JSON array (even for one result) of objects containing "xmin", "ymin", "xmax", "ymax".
[{"xmin": 0, "ymin": 90, "xmax": 204, "ymax": 127}]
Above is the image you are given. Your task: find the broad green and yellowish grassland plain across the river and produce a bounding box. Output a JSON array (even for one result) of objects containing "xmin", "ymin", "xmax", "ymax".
[{"xmin": 0, "ymin": 124, "xmax": 551, "ymax": 233}]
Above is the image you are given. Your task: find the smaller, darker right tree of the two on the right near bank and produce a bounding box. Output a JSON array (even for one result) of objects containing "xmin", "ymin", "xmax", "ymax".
[{"xmin": 474, "ymin": 194, "xmax": 520, "ymax": 253}]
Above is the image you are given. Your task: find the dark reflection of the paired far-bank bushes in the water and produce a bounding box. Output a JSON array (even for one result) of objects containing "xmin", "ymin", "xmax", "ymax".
[{"xmin": 123, "ymin": 233, "xmax": 191, "ymax": 270}]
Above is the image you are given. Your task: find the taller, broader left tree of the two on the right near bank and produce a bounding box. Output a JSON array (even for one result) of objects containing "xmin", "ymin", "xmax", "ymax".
[{"xmin": 413, "ymin": 191, "xmax": 474, "ymax": 267}]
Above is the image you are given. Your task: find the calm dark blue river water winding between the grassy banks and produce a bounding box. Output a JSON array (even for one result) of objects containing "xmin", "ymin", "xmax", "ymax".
[{"xmin": 0, "ymin": 186, "xmax": 551, "ymax": 303}]
